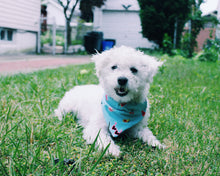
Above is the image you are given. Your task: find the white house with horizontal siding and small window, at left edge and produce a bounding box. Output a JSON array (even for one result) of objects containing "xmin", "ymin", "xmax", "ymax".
[{"xmin": 0, "ymin": 0, "xmax": 41, "ymax": 54}]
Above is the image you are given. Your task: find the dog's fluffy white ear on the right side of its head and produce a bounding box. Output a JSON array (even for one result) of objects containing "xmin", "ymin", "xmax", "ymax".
[{"xmin": 142, "ymin": 55, "xmax": 164, "ymax": 83}]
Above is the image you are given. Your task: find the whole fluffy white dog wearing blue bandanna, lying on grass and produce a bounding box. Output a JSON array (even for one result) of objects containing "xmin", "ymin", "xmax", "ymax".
[{"xmin": 55, "ymin": 46, "xmax": 165, "ymax": 156}]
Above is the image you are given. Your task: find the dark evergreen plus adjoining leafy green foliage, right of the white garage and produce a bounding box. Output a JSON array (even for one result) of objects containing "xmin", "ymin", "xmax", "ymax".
[{"xmin": 138, "ymin": 0, "xmax": 218, "ymax": 58}]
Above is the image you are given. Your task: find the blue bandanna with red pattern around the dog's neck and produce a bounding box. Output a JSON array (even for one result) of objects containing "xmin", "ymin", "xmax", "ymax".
[{"xmin": 102, "ymin": 95, "xmax": 147, "ymax": 137}]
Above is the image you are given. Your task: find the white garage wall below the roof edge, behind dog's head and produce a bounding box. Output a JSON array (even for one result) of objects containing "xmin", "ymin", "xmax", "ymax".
[{"xmin": 100, "ymin": 10, "xmax": 152, "ymax": 48}]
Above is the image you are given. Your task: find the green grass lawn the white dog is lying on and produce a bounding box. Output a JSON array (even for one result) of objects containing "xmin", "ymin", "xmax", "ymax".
[{"xmin": 0, "ymin": 56, "xmax": 220, "ymax": 175}]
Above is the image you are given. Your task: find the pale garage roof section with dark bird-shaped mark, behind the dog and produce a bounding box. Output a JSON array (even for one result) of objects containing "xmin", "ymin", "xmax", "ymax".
[{"xmin": 102, "ymin": 0, "xmax": 140, "ymax": 11}]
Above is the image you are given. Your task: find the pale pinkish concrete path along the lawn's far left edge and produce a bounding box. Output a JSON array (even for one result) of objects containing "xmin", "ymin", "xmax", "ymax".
[{"xmin": 0, "ymin": 55, "xmax": 91, "ymax": 75}]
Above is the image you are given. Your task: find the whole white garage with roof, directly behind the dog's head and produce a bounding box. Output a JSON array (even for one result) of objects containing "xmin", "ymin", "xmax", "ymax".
[{"xmin": 93, "ymin": 0, "xmax": 155, "ymax": 48}]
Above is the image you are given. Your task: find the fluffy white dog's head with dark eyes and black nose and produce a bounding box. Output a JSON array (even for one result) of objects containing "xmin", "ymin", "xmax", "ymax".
[{"xmin": 93, "ymin": 46, "xmax": 162, "ymax": 102}]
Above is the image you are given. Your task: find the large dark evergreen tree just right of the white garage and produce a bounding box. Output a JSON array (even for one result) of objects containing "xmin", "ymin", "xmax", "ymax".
[{"xmin": 138, "ymin": 0, "xmax": 191, "ymax": 47}]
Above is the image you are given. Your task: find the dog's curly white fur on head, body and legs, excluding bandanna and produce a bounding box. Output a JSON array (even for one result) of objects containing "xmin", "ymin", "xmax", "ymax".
[{"xmin": 55, "ymin": 46, "xmax": 165, "ymax": 156}]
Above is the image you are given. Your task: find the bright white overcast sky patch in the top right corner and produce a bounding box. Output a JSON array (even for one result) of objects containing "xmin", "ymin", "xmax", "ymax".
[{"xmin": 200, "ymin": 0, "xmax": 220, "ymax": 15}]
